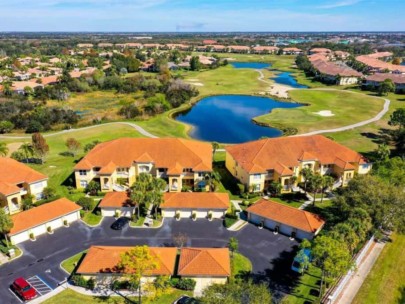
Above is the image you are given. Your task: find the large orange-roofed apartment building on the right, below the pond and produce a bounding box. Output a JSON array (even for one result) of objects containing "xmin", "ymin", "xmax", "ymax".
[{"xmin": 225, "ymin": 135, "xmax": 371, "ymax": 192}]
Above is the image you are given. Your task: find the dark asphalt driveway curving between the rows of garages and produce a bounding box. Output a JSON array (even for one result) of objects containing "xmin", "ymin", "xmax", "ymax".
[{"xmin": 0, "ymin": 217, "xmax": 298, "ymax": 303}]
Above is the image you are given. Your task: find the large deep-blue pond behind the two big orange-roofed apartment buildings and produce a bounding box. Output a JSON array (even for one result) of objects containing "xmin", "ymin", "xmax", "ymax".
[{"xmin": 176, "ymin": 95, "xmax": 302, "ymax": 143}]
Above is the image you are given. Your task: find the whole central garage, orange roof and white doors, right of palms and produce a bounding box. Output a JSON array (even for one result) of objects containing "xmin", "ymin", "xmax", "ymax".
[{"xmin": 160, "ymin": 192, "xmax": 230, "ymax": 219}]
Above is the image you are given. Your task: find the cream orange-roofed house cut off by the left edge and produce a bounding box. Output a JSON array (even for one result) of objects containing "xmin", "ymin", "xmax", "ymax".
[{"xmin": 0, "ymin": 157, "xmax": 48, "ymax": 214}]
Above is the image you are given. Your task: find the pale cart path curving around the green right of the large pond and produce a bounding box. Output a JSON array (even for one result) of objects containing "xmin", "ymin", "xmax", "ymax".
[{"xmin": 256, "ymin": 70, "xmax": 391, "ymax": 136}]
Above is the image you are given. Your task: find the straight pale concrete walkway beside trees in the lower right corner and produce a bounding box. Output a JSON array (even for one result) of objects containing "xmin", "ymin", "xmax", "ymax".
[{"xmin": 336, "ymin": 242, "xmax": 385, "ymax": 304}]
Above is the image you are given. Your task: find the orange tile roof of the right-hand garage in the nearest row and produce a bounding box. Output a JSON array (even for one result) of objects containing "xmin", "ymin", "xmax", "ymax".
[{"xmin": 177, "ymin": 248, "xmax": 231, "ymax": 277}]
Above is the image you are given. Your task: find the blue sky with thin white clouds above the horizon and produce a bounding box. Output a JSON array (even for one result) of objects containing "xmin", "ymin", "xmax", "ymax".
[{"xmin": 0, "ymin": 0, "xmax": 405, "ymax": 32}]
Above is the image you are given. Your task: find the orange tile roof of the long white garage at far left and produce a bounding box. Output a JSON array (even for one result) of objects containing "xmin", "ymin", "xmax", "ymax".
[{"xmin": 9, "ymin": 198, "xmax": 82, "ymax": 235}]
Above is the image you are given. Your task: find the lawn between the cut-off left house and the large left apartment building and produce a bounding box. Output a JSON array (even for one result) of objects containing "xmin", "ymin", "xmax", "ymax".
[{"xmin": 4, "ymin": 125, "xmax": 140, "ymax": 201}]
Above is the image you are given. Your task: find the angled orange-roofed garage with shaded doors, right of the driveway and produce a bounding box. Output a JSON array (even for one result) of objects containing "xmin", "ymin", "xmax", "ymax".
[{"xmin": 246, "ymin": 199, "xmax": 325, "ymax": 240}]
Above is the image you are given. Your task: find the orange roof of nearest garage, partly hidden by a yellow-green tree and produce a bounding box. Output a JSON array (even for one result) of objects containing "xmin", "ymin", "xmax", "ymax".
[{"xmin": 77, "ymin": 246, "xmax": 177, "ymax": 276}]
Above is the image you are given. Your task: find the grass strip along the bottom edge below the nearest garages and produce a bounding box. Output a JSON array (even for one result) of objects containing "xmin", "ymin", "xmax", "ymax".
[{"xmin": 43, "ymin": 289, "xmax": 191, "ymax": 304}]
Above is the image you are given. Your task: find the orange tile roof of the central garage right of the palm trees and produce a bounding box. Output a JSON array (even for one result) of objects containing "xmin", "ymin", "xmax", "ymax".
[{"xmin": 161, "ymin": 192, "xmax": 229, "ymax": 210}]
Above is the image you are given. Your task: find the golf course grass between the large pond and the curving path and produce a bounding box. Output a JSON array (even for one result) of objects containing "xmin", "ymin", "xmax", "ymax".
[{"xmin": 254, "ymin": 90, "xmax": 384, "ymax": 133}]
